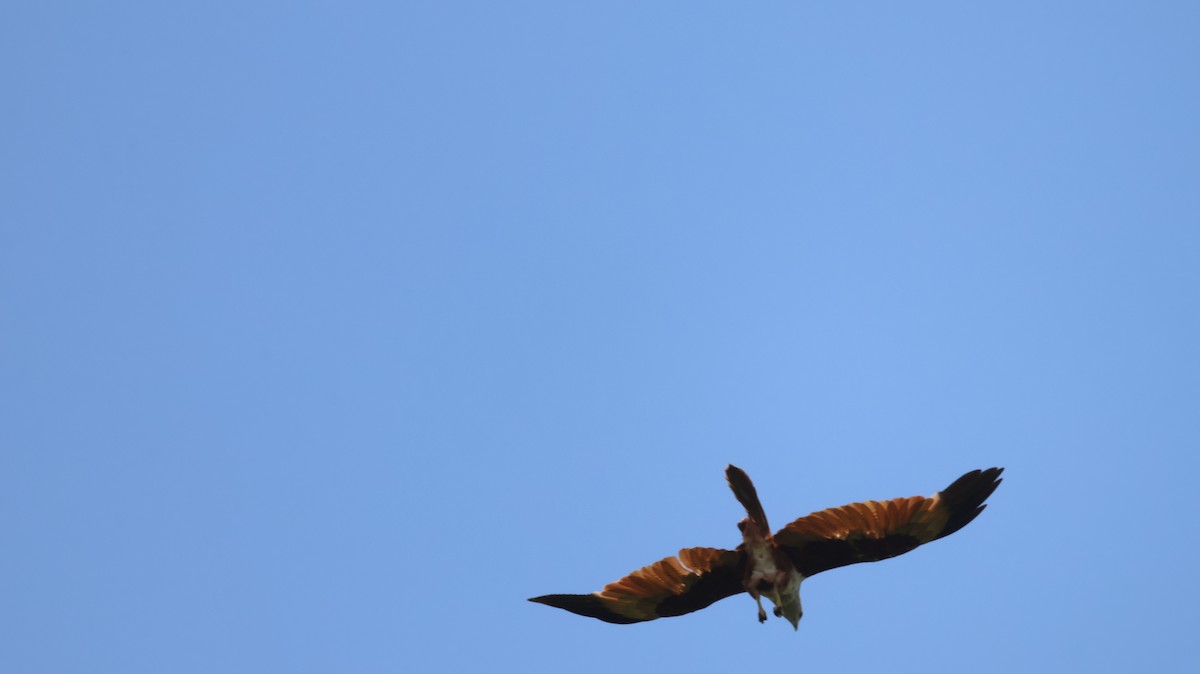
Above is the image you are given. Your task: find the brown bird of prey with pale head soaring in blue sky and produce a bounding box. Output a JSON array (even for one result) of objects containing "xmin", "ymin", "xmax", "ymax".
[{"xmin": 529, "ymin": 464, "xmax": 1004, "ymax": 630}]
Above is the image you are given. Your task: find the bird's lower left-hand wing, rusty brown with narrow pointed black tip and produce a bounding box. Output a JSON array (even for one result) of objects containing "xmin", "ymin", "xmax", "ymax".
[{"xmin": 529, "ymin": 548, "xmax": 745, "ymax": 625}]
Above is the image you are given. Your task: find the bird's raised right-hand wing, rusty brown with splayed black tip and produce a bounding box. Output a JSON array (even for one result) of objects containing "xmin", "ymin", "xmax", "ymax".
[{"xmin": 775, "ymin": 468, "xmax": 1004, "ymax": 578}]
